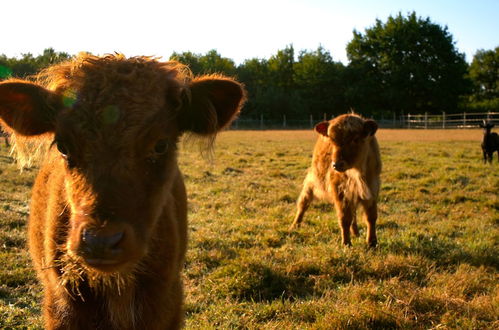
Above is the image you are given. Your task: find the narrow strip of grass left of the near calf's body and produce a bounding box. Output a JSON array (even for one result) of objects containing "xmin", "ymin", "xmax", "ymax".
[{"xmin": 0, "ymin": 148, "xmax": 42, "ymax": 329}]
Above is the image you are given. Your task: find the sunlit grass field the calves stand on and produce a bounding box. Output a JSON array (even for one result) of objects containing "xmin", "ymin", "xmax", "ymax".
[{"xmin": 0, "ymin": 130, "xmax": 499, "ymax": 329}]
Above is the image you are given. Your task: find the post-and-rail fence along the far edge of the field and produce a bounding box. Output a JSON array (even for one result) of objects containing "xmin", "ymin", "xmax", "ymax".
[{"xmin": 231, "ymin": 112, "xmax": 499, "ymax": 130}]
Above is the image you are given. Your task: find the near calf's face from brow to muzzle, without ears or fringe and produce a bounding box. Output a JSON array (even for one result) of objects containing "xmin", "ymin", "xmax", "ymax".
[{"xmin": 53, "ymin": 96, "xmax": 184, "ymax": 272}]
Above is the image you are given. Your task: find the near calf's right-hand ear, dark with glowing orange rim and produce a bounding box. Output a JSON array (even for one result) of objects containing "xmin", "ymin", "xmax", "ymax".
[{"xmin": 179, "ymin": 75, "xmax": 246, "ymax": 135}]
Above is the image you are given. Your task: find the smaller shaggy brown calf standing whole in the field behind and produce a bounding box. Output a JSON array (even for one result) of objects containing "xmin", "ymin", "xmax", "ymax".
[{"xmin": 291, "ymin": 114, "xmax": 381, "ymax": 247}]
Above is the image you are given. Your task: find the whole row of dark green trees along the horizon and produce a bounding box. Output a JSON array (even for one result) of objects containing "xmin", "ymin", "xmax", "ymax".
[{"xmin": 0, "ymin": 12, "xmax": 499, "ymax": 119}]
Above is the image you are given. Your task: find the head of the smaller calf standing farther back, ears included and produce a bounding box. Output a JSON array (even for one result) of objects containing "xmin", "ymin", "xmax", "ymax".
[{"xmin": 315, "ymin": 115, "xmax": 378, "ymax": 172}]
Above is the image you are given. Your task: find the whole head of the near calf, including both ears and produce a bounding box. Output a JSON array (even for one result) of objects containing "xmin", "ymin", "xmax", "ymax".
[{"xmin": 0, "ymin": 59, "xmax": 244, "ymax": 273}]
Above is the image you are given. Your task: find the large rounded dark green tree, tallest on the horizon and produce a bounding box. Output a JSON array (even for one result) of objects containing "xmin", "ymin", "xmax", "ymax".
[{"xmin": 347, "ymin": 12, "xmax": 469, "ymax": 114}]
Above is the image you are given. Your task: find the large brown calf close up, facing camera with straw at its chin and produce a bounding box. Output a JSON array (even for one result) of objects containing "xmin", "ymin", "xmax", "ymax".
[{"xmin": 0, "ymin": 55, "xmax": 245, "ymax": 329}]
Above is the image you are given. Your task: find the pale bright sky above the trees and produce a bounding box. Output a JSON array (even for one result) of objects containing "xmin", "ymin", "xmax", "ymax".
[{"xmin": 0, "ymin": 0, "xmax": 499, "ymax": 64}]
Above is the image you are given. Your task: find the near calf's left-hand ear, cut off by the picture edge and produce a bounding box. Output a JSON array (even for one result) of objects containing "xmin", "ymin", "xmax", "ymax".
[{"xmin": 0, "ymin": 80, "xmax": 63, "ymax": 136}]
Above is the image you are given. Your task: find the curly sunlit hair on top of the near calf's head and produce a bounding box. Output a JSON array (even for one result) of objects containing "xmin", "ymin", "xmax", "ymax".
[{"xmin": 43, "ymin": 54, "xmax": 191, "ymax": 133}]
